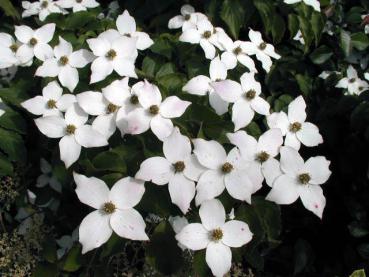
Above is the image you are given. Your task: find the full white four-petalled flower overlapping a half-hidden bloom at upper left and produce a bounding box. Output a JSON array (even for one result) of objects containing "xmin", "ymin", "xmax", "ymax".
[{"xmin": 87, "ymin": 33, "xmax": 138, "ymax": 84}]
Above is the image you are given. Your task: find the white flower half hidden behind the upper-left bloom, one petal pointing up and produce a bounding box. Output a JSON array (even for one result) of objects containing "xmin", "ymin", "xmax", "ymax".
[{"xmin": 116, "ymin": 10, "xmax": 154, "ymax": 50}]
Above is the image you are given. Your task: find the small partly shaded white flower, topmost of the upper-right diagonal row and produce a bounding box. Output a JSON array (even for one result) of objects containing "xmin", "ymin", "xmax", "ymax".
[{"xmin": 168, "ymin": 5, "xmax": 206, "ymax": 31}]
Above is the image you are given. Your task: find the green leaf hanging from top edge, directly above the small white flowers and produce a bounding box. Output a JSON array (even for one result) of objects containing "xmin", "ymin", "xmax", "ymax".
[{"xmin": 220, "ymin": 0, "xmax": 245, "ymax": 39}]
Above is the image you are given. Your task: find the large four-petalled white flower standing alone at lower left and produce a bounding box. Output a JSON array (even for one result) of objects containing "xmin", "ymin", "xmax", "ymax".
[{"xmin": 73, "ymin": 172, "xmax": 149, "ymax": 254}]
